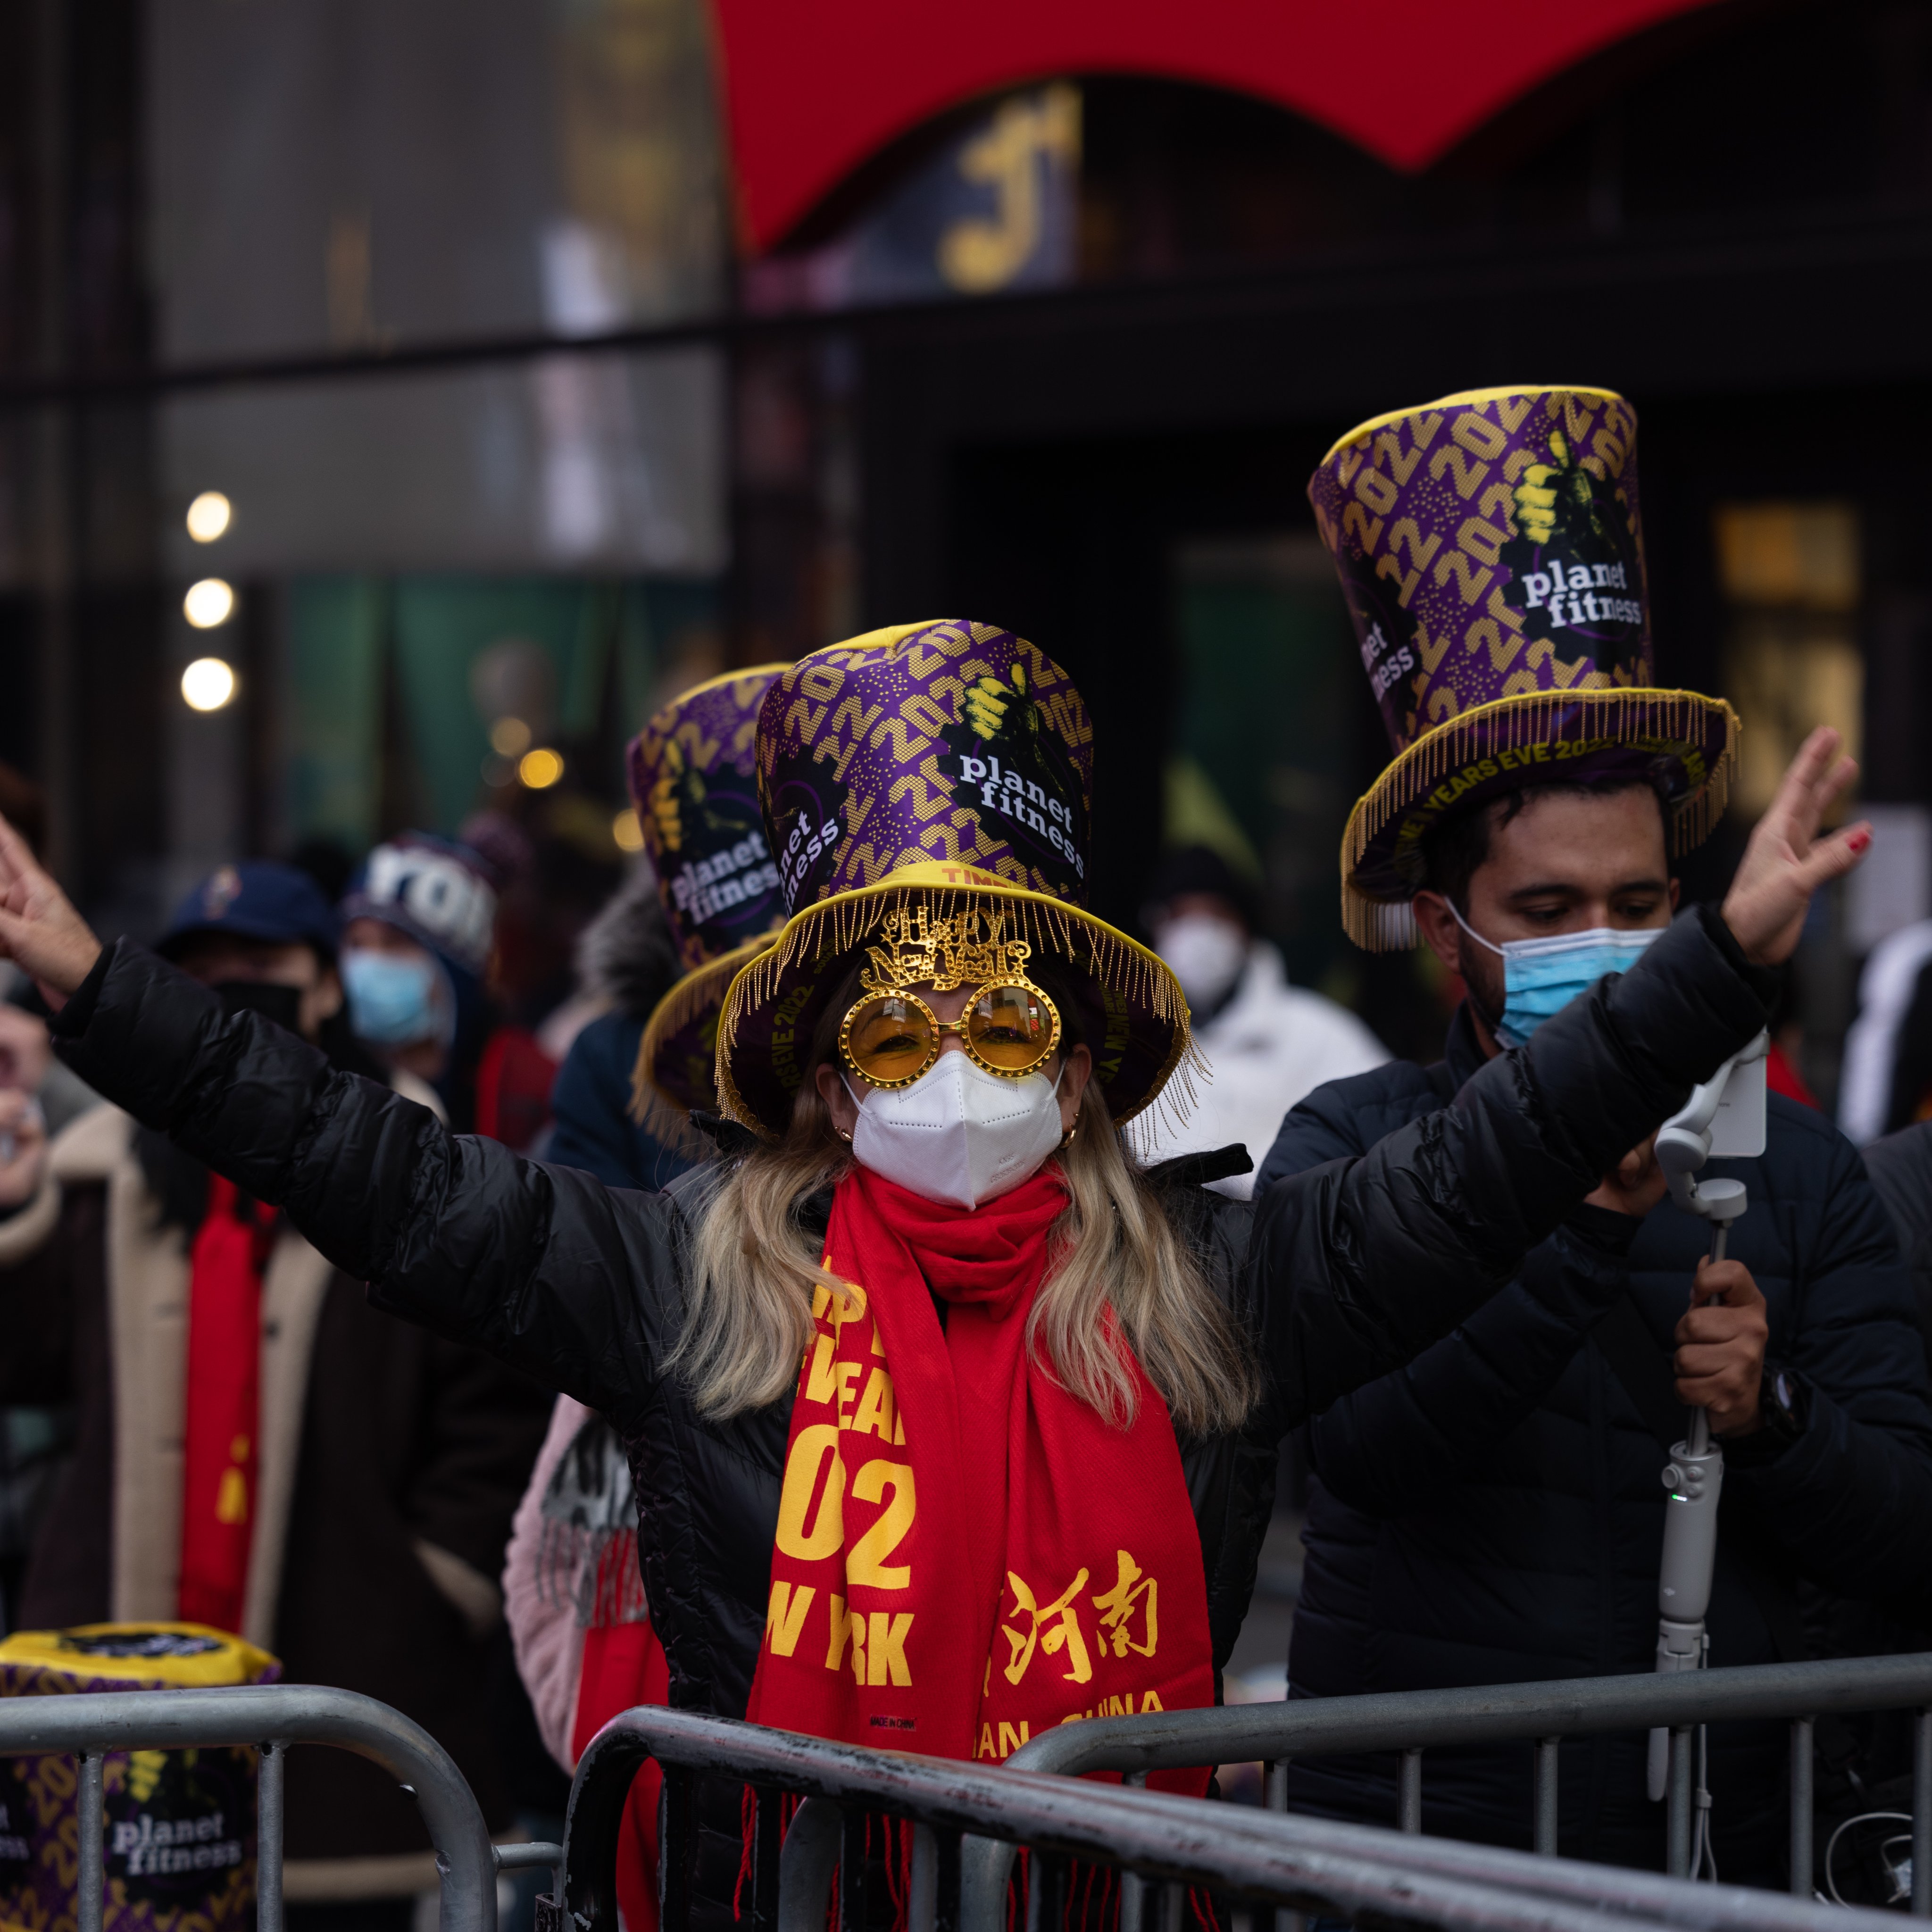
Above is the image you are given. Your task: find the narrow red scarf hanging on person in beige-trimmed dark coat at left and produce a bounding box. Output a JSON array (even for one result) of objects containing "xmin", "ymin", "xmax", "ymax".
[{"xmin": 178, "ymin": 1174, "xmax": 275, "ymax": 1631}]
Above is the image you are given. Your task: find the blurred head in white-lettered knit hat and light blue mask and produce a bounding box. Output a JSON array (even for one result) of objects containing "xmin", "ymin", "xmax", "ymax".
[{"xmin": 342, "ymin": 833, "xmax": 497, "ymax": 1132}]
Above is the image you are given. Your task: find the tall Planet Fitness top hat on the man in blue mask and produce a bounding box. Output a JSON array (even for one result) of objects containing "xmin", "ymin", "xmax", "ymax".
[{"xmin": 1308, "ymin": 384, "xmax": 1739, "ymax": 950}]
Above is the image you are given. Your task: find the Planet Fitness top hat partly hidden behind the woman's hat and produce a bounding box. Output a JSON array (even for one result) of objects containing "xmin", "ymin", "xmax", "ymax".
[{"xmin": 628, "ymin": 665, "xmax": 784, "ymax": 1130}]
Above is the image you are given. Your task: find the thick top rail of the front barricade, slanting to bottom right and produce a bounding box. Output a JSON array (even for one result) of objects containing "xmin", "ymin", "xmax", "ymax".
[{"xmin": 566, "ymin": 1710, "xmax": 1895, "ymax": 1932}]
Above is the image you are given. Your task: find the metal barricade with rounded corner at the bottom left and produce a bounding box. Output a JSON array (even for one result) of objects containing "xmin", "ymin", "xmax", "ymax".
[{"xmin": 0, "ymin": 1685, "xmax": 514, "ymax": 1932}]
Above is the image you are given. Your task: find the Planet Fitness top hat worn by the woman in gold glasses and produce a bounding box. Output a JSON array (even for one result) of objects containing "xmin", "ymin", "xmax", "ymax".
[{"xmin": 719, "ymin": 618, "xmax": 1190, "ymax": 1138}]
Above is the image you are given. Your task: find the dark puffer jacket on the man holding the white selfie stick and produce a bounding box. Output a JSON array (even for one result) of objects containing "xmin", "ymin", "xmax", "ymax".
[{"xmin": 1262, "ymin": 989, "xmax": 1932, "ymax": 1880}]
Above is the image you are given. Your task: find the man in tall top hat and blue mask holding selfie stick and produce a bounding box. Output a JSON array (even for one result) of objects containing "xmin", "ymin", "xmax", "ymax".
[{"xmin": 1260, "ymin": 392, "xmax": 1932, "ymax": 1884}]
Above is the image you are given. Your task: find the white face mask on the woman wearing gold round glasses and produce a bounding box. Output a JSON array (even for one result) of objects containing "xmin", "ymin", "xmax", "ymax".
[{"xmin": 846, "ymin": 1053, "xmax": 1065, "ymax": 1208}]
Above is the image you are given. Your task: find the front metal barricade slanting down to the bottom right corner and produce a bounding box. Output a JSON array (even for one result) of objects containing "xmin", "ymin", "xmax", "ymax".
[{"xmin": 552, "ymin": 1708, "xmax": 1895, "ymax": 1932}]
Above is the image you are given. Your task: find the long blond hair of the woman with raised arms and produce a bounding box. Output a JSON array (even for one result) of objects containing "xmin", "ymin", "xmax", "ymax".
[{"xmin": 666, "ymin": 981, "xmax": 1260, "ymax": 1435}]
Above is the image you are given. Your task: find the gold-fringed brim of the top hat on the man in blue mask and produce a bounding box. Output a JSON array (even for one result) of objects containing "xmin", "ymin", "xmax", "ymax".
[{"xmin": 1341, "ymin": 684, "xmax": 1739, "ymax": 952}]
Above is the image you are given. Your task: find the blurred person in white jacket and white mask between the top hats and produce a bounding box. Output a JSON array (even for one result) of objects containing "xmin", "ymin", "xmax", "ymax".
[{"xmin": 1142, "ymin": 846, "xmax": 1389, "ymax": 1200}]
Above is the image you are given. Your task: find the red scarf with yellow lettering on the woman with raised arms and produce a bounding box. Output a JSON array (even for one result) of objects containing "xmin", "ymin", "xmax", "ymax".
[{"xmin": 748, "ymin": 1167, "xmax": 1213, "ymax": 1791}]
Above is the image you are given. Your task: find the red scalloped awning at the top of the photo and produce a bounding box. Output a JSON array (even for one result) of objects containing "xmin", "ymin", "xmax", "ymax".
[{"xmin": 715, "ymin": 0, "xmax": 1731, "ymax": 249}]
